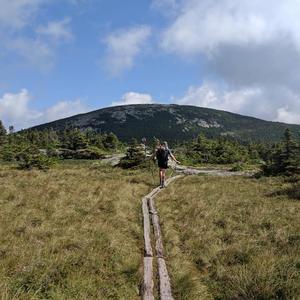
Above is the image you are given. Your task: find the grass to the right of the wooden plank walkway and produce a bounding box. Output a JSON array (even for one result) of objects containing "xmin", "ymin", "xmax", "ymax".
[{"xmin": 156, "ymin": 176, "xmax": 300, "ymax": 300}]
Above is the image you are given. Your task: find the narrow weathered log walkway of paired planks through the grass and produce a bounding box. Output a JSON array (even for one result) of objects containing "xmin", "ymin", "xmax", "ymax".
[{"xmin": 142, "ymin": 175, "xmax": 182, "ymax": 300}]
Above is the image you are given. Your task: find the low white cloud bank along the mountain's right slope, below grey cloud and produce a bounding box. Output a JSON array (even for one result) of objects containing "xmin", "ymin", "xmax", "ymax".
[{"xmin": 176, "ymin": 82, "xmax": 300, "ymax": 124}]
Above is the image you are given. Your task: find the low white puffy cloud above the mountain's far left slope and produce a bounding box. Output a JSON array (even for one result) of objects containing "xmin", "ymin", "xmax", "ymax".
[{"xmin": 0, "ymin": 89, "xmax": 88, "ymax": 129}]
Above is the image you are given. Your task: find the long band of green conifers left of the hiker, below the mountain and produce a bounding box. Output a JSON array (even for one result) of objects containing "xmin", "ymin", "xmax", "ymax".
[{"xmin": 0, "ymin": 120, "xmax": 120, "ymax": 169}]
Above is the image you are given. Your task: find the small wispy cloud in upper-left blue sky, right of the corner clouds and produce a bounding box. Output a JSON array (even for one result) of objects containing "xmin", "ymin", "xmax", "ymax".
[{"xmin": 36, "ymin": 18, "xmax": 73, "ymax": 41}]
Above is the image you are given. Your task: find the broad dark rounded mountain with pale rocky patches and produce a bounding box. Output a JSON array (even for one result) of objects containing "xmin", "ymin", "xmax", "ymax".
[{"xmin": 33, "ymin": 104, "xmax": 300, "ymax": 142}]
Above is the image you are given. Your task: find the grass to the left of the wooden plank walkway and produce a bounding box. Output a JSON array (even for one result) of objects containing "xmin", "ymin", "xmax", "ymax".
[{"xmin": 0, "ymin": 162, "xmax": 159, "ymax": 299}]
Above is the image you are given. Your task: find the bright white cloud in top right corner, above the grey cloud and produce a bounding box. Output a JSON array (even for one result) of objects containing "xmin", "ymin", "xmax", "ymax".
[{"xmin": 163, "ymin": 0, "xmax": 300, "ymax": 54}]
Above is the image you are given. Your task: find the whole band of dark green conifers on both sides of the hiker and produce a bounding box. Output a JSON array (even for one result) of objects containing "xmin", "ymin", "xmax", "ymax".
[{"xmin": 0, "ymin": 121, "xmax": 300, "ymax": 175}]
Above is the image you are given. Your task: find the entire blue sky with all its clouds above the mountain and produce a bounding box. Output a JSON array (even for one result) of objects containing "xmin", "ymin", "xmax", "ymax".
[{"xmin": 0, "ymin": 0, "xmax": 300, "ymax": 129}]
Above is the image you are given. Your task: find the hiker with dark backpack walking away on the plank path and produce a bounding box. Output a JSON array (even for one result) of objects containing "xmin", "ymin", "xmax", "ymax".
[{"xmin": 155, "ymin": 142, "xmax": 180, "ymax": 188}]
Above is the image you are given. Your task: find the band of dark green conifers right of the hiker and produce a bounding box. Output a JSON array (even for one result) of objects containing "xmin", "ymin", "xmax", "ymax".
[{"xmin": 178, "ymin": 129, "xmax": 300, "ymax": 175}]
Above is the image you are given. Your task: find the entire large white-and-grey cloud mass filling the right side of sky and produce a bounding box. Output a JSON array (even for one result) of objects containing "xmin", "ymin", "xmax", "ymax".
[{"xmin": 161, "ymin": 0, "xmax": 300, "ymax": 122}]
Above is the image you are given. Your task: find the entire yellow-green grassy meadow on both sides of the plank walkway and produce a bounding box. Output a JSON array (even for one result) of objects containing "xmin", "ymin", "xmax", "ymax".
[{"xmin": 0, "ymin": 161, "xmax": 300, "ymax": 300}]
